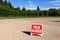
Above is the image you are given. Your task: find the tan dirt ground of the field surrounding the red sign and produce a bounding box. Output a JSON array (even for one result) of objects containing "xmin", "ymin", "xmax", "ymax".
[{"xmin": 0, "ymin": 18, "xmax": 60, "ymax": 40}]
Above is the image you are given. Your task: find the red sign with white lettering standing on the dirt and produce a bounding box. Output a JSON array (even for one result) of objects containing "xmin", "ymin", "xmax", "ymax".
[{"xmin": 31, "ymin": 24, "xmax": 42, "ymax": 36}]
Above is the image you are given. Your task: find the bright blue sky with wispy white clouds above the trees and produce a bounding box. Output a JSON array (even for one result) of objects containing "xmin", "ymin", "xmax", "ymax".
[{"xmin": 7, "ymin": 0, "xmax": 60, "ymax": 10}]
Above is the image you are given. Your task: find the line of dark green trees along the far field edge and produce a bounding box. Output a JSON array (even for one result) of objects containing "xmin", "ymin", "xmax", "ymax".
[{"xmin": 0, "ymin": 0, "xmax": 60, "ymax": 17}]
